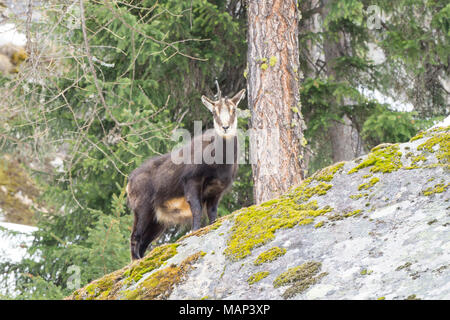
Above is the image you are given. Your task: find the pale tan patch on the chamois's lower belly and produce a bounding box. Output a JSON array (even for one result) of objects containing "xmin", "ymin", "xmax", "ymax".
[{"xmin": 156, "ymin": 197, "xmax": 192, "ymax": 225}]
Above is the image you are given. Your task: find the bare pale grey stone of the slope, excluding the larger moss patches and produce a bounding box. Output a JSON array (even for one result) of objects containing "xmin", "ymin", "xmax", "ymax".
[{"xmin": 68, "ymin": 121, "xmax": 450, "ymax": 299}]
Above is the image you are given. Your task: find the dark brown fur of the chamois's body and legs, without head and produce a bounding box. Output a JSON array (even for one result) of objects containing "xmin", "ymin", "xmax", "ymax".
[{"xmin": 127, "ymin": 130, "xmax": 238, "ymax": 259}]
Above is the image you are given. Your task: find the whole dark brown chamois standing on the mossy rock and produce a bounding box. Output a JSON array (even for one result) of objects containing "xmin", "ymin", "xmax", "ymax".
[{"xmin": 127, "ymin": 81, "xmax": 245, "ymax": 260}]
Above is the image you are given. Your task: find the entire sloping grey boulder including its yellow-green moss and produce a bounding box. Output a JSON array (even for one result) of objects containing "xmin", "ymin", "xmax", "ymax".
[{"xmin": 68, "ymin": 122, "xmax": 450, "ymax": 299}]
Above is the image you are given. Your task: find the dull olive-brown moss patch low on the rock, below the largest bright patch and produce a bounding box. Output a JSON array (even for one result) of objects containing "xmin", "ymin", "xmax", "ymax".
[{"xmin": 273, "ymin": 261, "xmax": 327, "ymax": 299}]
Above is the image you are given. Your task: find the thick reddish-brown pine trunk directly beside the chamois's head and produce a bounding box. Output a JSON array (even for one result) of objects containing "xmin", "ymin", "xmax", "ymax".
[{"xmin": 247, "ymin": 0, "xmax": 304, "ymax": 203}]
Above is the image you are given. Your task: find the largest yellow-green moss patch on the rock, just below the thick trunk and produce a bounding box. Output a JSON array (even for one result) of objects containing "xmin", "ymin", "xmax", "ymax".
[{"xmin": 224, "ymin": 188, "xmax": 332, "ymax": 260}]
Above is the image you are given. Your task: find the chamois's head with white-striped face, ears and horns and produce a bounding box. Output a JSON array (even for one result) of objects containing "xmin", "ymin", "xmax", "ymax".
[{"xmin": 202, "ymin": 80, "xmax": 245, "ymax": 138}]
